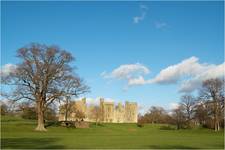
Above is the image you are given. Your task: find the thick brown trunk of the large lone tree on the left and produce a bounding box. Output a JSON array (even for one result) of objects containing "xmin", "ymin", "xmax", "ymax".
[{"xmin": 35, "ymin": 102, "xmax": 47, "ymax": 131}]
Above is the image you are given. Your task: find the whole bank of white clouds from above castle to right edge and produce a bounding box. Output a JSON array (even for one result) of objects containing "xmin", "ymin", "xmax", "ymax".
[{"xmin": 102, "ymin": 56, "xmax": 225, "ymax": 93}]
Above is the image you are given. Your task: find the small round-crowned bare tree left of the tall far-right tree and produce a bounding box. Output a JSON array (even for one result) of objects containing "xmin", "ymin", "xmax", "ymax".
[{"xmin": 180, "ymin": 94, "xmax": 195, "ymax": 124}]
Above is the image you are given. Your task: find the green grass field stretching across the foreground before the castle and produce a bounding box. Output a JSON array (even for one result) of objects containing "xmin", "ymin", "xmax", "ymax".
[{"xmin": 1, "ymin": 117, "xmax": 224, "ymax": 149}]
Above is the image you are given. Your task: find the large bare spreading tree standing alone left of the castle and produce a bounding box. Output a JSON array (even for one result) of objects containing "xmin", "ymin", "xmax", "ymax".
[{"xmin": 1, "ymin": 43, "xmax": 88, "ymax": 131}]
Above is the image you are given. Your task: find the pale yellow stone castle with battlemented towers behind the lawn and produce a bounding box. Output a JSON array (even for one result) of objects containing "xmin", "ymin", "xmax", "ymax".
[{"xmin": 59, "ymin": 98, "xmax": 138, "ymax": 123}]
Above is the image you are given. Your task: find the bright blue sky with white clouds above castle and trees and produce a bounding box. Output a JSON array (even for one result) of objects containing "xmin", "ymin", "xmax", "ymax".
[{"xmin": 1, "ymin": 1, "xmax": 224, "ymax": 111}]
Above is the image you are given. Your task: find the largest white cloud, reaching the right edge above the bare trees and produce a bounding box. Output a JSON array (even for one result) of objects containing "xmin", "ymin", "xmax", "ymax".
[{"xmin": 150, "ymin": 57, "xmax": 224, "ymax": 92}]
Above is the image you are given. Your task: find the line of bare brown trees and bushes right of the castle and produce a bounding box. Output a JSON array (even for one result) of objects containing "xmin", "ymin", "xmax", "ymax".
[{"xmin": 138, "ymin": 78, "xmax": 224, "ymax": 131}]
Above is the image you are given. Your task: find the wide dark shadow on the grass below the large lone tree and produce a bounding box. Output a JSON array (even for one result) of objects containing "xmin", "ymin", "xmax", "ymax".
[{"xmin": 1, "ymin": 138, "xmax": 64, "ymax": 149}]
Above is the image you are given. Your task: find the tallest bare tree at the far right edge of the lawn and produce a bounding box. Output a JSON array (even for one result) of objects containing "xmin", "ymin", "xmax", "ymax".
[{"xmin": 200, "ymin": 79, "xmax": 224, "ymax": 131}]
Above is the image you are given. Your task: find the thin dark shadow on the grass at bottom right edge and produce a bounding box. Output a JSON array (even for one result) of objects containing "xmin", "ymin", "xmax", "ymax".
[{"xmin": 149, "ymin": 145, "xmax": 198, "ymax": 149}]
